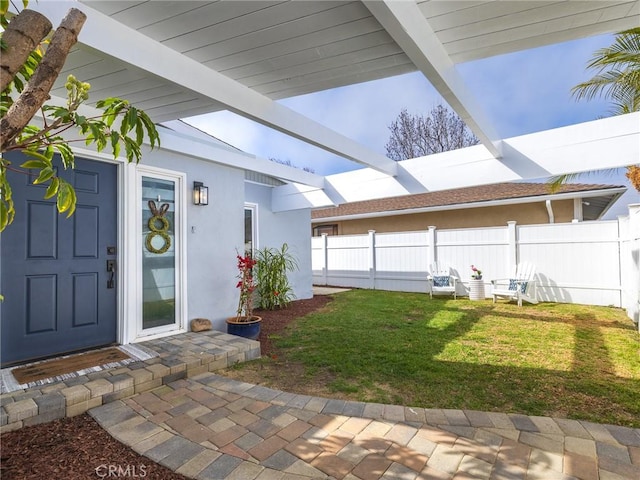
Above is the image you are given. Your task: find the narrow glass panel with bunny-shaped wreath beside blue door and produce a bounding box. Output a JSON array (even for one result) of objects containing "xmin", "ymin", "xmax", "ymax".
[{"xmin": 142, "ymin": 176, "xmax": 177, "ymax": 333}]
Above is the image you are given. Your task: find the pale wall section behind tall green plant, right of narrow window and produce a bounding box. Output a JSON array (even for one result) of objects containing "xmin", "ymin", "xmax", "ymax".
[{"xmin": 245, "ymin": 183, "xmax": 313, "ymax": 299}]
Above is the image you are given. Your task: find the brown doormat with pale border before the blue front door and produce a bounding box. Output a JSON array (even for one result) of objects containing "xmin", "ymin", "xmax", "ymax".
[{"xmin": 0, "ymin": 345, "xmax": 158, "ymax": 393}]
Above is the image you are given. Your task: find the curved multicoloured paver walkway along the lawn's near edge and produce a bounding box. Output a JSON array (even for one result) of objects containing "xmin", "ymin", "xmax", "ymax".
[{"xmin": 89, "ymin": 372, "xmax": 640, "ymax": 480}]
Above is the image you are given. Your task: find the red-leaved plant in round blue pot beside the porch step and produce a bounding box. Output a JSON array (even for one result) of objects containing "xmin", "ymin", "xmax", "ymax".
[{"xmin": 227, "ymin": 254, "xmax": 262, "ymax": 340}]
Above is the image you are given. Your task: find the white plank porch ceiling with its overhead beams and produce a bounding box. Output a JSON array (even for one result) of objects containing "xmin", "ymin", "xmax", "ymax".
[{"xmin": 17, "ymin": 0, "xmax": 640, "ymax": 196}]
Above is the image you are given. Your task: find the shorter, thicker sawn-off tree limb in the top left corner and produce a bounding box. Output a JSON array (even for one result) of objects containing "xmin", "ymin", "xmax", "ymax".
[{"xmin": 0, "ymin": 10, "xmax": 53, "ymax": 91}]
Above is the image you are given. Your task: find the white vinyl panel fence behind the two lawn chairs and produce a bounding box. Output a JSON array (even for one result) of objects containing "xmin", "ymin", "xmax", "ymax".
[{"xmin": 311, "ymin": 205, "xmax": 640, "ymax": 323}]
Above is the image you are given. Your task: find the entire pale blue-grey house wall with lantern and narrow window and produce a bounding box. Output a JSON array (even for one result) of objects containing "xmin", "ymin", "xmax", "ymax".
[{"xmin": 135, "ymin": 151, "xmax": 313, "ymax": 331}]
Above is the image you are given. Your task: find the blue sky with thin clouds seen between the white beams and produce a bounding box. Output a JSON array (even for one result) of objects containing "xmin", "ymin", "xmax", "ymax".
[{"xmin": 185, "ymin": 35, "xmax": 640, "ymax": 219}]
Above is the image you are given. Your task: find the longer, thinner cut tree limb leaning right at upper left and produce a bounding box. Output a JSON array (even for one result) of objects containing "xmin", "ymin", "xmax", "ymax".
[{"xmin": 0, "ymin": 8, "xmax": 87, "ymax": 152}]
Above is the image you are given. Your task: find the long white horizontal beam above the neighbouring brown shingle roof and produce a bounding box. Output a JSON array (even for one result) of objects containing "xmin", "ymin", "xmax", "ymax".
[{"xmin": 272, "ymin": 112, "xmax": 640, "ymax": 211}]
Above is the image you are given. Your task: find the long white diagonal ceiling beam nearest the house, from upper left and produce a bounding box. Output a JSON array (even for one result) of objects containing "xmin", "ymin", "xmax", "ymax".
[{"xmin": 34, "ymin": 1, "xmax": 397, "ymax": 175}]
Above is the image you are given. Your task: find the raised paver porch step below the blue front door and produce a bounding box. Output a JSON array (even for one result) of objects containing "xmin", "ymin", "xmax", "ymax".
[{"xmin": 0, "ymin": 330, "xmax": 260, "ymax": 433}]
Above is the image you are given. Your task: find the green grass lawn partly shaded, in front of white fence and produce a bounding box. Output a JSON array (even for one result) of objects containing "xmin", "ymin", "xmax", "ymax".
[{"xmin": 239, "ymin": 290, "xmax": 640, "ymax": 427}]
